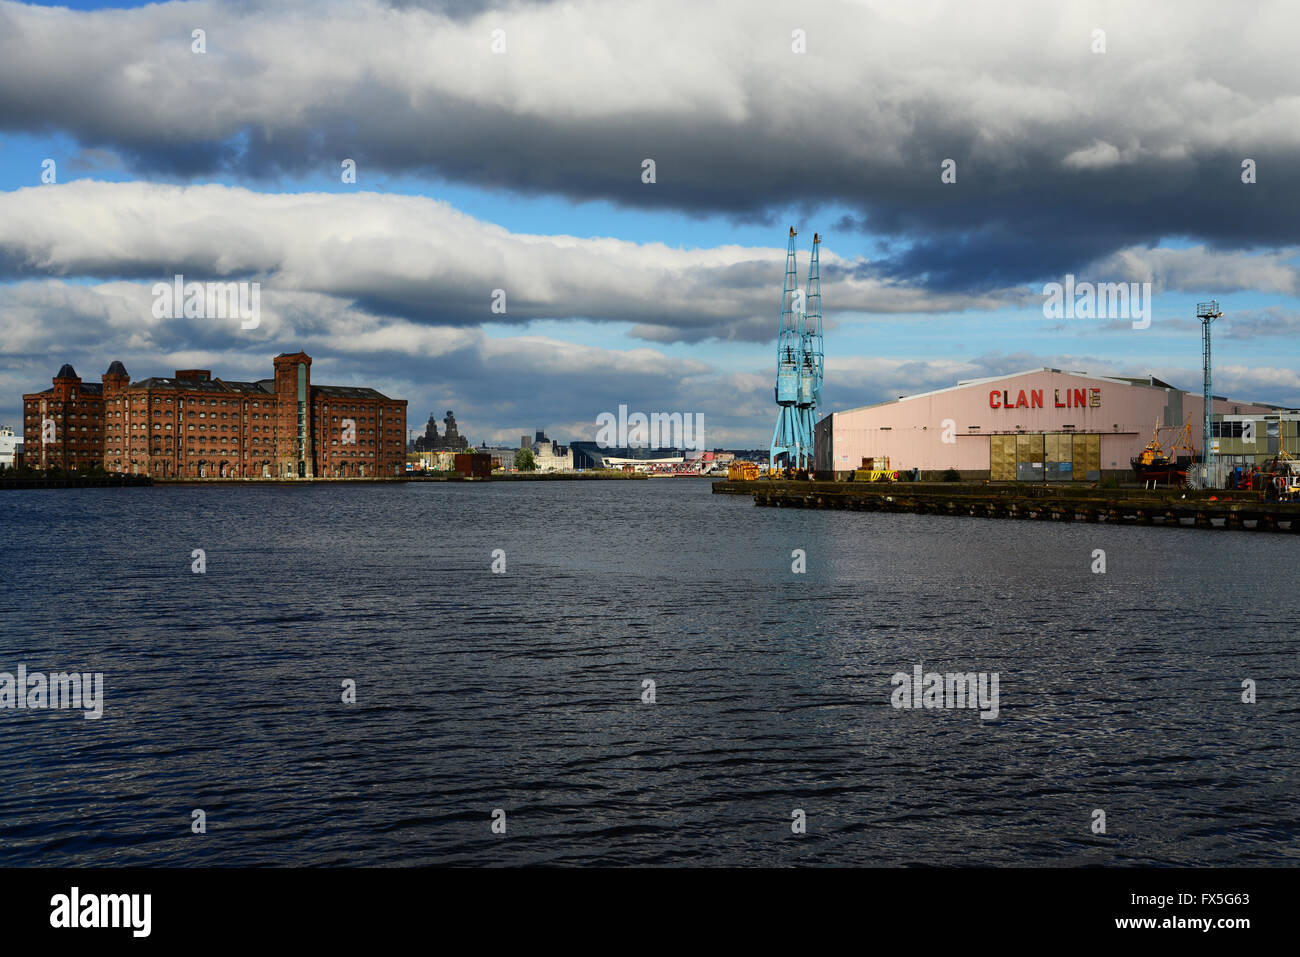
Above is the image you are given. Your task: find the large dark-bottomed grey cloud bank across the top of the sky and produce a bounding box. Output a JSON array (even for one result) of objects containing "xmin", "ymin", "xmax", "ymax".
[{"xmin": 0, "ymin": 0, "xmax": 1300, "ymax": 293}]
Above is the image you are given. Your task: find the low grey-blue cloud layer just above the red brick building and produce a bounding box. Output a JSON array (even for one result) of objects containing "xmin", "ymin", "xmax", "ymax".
[{"xmin": 0, "ymin": 280, "xmax": 771, "ymax": 443}]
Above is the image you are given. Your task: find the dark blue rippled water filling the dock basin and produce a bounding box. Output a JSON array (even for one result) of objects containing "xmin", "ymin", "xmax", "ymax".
[{"xmin": 0, "ymin": 480, "xmax": 1300, "ymax": 865}]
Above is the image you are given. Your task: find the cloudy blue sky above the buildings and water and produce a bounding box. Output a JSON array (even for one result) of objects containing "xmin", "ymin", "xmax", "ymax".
[{"xmin": 0, "ymin": 0, "xmax": 1300, "ymax": 449}]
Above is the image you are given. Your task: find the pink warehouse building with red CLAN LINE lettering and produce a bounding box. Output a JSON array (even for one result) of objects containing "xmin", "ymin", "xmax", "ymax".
[{"xmin": 814, "ymin": 368, "xmax": 1286, "ymax": 481}]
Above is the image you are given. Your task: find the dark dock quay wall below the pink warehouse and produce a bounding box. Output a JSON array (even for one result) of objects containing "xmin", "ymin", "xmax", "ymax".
[{"xmin": 712, "ymin": 480, "xmax": 1300, "ymax": 533}]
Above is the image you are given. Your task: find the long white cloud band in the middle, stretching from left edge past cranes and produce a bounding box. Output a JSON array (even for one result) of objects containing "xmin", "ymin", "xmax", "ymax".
[{"xmin": 0, "ymin": 181, "xmax": 1024, "ymax": 343}]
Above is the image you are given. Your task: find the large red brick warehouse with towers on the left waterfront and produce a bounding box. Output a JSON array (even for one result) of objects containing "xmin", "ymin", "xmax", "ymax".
[{"xmin": 22, "ymin": 352, "xmax": 407, "ymax": 479}]
